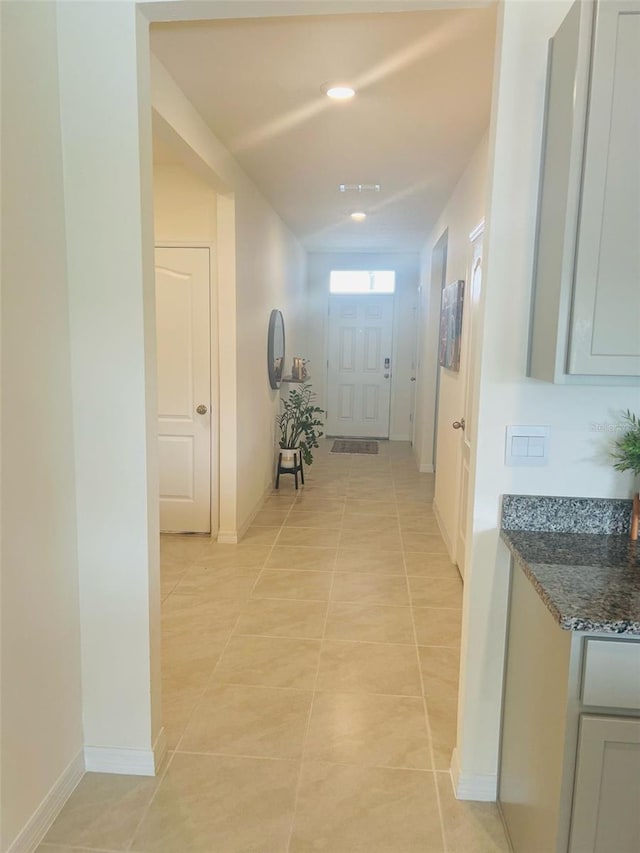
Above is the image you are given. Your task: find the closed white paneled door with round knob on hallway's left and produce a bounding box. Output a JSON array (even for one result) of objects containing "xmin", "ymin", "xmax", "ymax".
[{"xmin": 156, "ymin": 243, "xmax": 211, "ymax": 533}]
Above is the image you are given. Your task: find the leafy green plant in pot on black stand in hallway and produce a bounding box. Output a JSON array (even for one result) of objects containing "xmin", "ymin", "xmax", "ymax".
[{"xmin": 276, "ymin": 382, "xmax": 324, "ymax": 468}]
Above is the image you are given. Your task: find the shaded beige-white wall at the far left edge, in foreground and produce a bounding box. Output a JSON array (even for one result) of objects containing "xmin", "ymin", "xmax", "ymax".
[{"xmin": 0, "ymin": 3, "xmax": 82, "ymax": 850}]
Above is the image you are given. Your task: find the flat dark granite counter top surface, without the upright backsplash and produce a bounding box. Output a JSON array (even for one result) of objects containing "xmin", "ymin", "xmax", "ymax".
[{"xmin": 502, "ymin": 529, "xmax": 640, "ymax": 637}]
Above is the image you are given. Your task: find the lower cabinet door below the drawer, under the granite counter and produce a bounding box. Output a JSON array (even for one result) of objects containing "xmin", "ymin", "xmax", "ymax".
[{"xmin": 569, "ymin": 715, "xmax": 640, "ymax": 853}]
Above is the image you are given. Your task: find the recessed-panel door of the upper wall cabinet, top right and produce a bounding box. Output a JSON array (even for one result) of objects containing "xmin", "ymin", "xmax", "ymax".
[{"xmin": 568, "ymin": 0, "xmax": 640, "ymax": 376}]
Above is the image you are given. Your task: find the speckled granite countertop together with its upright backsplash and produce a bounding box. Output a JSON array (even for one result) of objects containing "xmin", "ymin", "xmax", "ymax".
[{"xmin": 501, "ymin": 495, "xmax": 640, "ymax": 637}]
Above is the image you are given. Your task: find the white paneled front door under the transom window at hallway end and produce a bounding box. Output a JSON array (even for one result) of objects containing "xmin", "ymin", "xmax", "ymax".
[{"xmin": 326, "ymin": 294, "xmax": 393, "ymax": 438}]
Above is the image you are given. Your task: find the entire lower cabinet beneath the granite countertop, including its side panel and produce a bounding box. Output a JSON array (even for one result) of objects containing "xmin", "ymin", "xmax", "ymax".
[{"xmin": 498, "ymin": 567, "xmax": 640, "ymax": 853}]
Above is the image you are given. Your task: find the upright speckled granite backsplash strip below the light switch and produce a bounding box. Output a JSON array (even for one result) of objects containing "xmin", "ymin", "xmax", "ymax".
[{"xmin": 502, "ymin": 495, "xmax": 632, "ymax": 533}]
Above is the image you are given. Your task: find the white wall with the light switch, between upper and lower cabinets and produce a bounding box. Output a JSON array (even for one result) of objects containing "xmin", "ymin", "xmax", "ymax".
[{"xmin": 457, "ymin": 0, "xmax": 640, "ymax": 795}]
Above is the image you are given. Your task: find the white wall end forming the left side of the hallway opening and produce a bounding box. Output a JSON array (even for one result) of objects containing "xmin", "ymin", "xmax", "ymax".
[{"xmin": 56, "ymin": 2, "xmax": 162, "ymax": 774}]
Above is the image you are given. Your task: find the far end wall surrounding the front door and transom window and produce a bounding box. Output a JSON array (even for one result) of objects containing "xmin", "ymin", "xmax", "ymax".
[{"xmin": 306, "ymin": 252, "xmax": 419, "ymax": 441}]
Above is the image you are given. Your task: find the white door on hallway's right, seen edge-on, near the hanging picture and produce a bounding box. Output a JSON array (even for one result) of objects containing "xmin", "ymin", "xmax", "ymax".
[{"xmin": 456, "ymin": 225, "xmax": 484, "ymax": 577}]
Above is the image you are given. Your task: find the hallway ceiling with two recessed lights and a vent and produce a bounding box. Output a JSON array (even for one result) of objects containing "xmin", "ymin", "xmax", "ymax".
[{"xmin": 151, "ymin": 5, "xmax": 496, "ymax": 251}]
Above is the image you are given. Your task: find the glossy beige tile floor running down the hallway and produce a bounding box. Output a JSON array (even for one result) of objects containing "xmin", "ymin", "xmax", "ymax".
[{"xmin": 39, "ymin": 441, "xmax": 508, "ymax": 853}]
